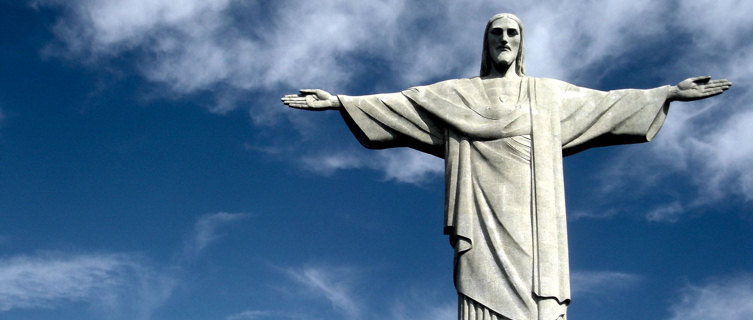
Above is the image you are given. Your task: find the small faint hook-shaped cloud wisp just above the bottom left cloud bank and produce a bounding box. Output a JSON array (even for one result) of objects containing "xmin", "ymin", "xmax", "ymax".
[{"xmin": 183, "ymin": 212, "xmax": 248, "ymax": 259}]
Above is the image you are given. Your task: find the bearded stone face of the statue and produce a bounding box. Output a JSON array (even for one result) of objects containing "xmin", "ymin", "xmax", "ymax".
[{"xmin": 487, "ymin": 18, "xmax": 520, "ymax": 67}]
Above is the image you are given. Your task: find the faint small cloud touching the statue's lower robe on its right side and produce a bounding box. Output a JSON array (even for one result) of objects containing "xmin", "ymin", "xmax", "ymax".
[{"xmin": 570, "ymin": 271, "xmax": 642, "ymax": 296}]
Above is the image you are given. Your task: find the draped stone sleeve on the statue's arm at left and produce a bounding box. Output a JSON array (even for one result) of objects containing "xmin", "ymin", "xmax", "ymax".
[{"xmin": 337, "ymin": 93, "xmax": 445, "ymax": 158}]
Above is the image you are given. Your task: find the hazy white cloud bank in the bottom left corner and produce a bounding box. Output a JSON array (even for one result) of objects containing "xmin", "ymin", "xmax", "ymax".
[{"xmin": 0, "ymin": 253, "xmax": 175, "ymax": 319}]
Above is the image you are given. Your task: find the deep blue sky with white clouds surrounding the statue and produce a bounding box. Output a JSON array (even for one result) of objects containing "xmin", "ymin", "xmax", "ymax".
[{"xmin": 0, "ymin": 0, "xmax": 753, "ymax": 320}]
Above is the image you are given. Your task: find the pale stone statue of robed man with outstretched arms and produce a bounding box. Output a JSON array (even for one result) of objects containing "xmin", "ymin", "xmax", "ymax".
[{"xmin": 282, "ymin": 13, "xmax": 731, "ymax": 320}]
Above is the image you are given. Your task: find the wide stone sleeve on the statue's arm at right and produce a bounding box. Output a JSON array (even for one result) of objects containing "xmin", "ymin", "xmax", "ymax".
[{"xmin": 559, "ymin": 85, "xmax": 669, "ymax": 156}]
